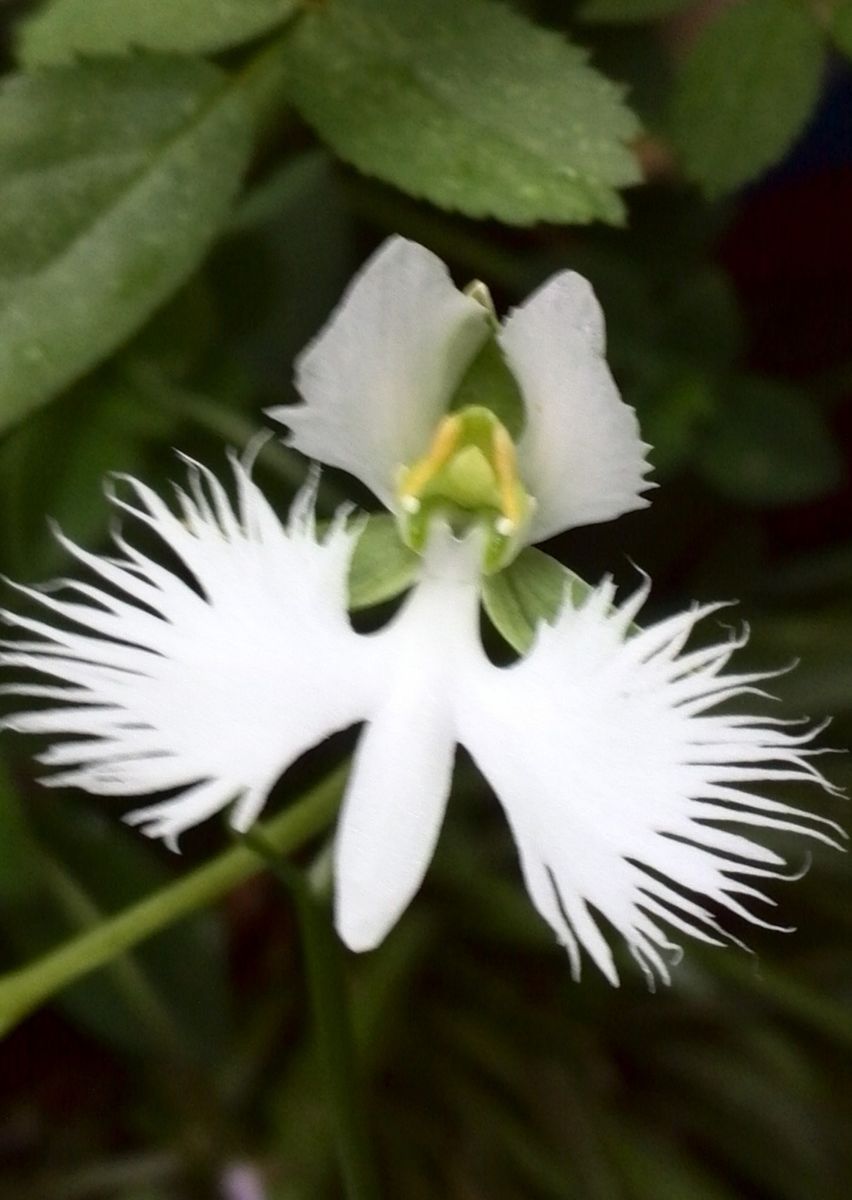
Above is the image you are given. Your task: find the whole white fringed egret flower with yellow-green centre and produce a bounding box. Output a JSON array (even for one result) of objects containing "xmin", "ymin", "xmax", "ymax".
[{"xmin": 2, "ymin": 239, "xmax": 840, "ymax": 984}]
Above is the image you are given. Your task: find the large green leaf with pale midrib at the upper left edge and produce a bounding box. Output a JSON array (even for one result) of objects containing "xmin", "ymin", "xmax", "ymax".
[{"xmin": 0, "ymin": 56, "xmax": 252, "ymax": 428}]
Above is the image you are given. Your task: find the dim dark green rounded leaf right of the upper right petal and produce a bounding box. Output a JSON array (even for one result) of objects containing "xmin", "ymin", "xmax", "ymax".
[{"xmin": 697, "ymin": 377, "xmax": 844, "ymax": 505}]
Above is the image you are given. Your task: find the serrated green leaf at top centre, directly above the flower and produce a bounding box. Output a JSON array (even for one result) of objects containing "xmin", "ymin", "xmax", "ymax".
[{"xmin": 282, "ymin": 0, "xmax": 638, "ymax": 224}]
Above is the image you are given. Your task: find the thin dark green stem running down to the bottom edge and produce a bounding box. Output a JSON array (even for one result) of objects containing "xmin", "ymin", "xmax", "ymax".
[{"xmin": 244, "ymin": 830, "xmax": 380, "ymax": 1200}]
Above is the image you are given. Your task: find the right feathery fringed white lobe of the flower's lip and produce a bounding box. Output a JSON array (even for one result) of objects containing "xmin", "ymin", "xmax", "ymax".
[{"xmin": 457, "ymin": 584, "xmax": 840, "ymax": 983}]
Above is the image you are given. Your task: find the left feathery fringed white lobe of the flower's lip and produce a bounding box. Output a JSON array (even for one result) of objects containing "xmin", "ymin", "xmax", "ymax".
[{"xmin": 0, "ymin": 462, "xmax": 380, "ymax": 845}]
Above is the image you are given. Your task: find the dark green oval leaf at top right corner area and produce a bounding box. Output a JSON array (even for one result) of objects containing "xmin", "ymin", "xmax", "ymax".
[{"xmin": 672, "ymin": 0, "xmax": 824, "ymax": 196}]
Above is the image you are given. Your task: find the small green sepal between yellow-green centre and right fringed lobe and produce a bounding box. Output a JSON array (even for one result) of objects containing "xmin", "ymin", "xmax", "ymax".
[{"xmin": 482, "ymin": 547, "xmax": 592, "ymax": 654}]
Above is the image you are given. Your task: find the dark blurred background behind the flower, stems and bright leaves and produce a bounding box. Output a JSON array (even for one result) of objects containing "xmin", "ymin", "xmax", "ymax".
[{"xmin": 0, "ymin": 2, "xmax": 852, "ymax": 1200}]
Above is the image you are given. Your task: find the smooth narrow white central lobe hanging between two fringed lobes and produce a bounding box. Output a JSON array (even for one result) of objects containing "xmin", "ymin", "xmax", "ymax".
[{"xmin": 335, "ymin": 529, "xmax": 481, "ymax": 950}]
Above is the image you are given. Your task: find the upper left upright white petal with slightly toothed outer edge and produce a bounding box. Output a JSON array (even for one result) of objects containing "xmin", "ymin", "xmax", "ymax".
[{"xmin": 269, "ymin": 238, "xmax": 488, "ymax": 508}]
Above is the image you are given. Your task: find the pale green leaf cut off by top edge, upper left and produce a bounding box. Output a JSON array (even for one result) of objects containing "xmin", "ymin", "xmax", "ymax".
[{"xmin": 18, "ymin": 0, "xmax": 299, "ymax": 66}]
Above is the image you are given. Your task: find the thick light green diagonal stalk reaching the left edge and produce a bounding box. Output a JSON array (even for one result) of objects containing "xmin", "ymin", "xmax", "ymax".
[{"xmin": 0, "ymin": 763, "xmax": 348, "ymax": 1037}]
